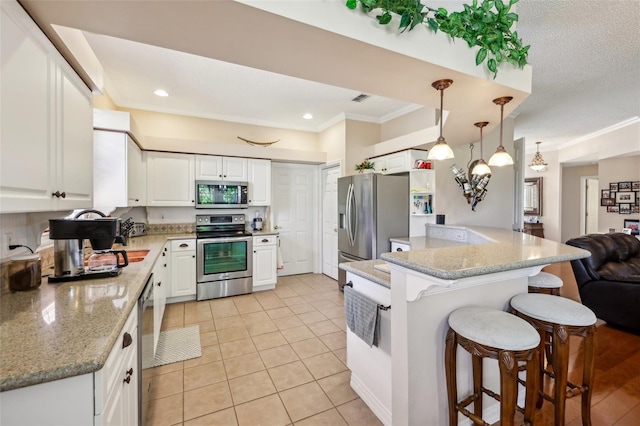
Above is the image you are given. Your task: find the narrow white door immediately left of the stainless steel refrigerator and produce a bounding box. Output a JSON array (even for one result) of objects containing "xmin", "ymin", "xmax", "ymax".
[{"xmin": 322, "ymin": 166, "xmax": 340, "ymax": 280}]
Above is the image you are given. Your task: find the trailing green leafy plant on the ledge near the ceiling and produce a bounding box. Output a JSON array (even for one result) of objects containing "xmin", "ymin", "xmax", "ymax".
[{"xmin": 346, "ymin": 0, "xmax": 530, "ymax": 78}]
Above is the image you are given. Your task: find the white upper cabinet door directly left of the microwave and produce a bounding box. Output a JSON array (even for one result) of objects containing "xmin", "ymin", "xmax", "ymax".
[{"xmin": 147, "ymin": 152, "xmax": 195, "ymax": 206}]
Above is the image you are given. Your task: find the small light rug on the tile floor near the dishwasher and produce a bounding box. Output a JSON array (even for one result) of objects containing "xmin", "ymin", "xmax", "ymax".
[{"xmin": 142, "ymin": 325, "xmax": 202, "ymax": 369}]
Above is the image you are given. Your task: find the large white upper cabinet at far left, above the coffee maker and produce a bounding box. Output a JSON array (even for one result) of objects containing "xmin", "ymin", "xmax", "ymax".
[{"xmin": 0, "ymin": 2, "xmax": 93, "ymax": 213}]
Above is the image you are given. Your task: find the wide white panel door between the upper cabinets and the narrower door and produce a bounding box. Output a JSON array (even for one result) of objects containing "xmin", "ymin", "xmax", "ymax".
[{"xmin": 271, "ymin": 163, "xmax": 317, "ymax": 276}]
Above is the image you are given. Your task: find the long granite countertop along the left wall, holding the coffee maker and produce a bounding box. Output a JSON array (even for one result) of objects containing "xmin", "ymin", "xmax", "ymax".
[{"xmin": 0, "ymin": 234, "xmax": 195, "ymax": 391}]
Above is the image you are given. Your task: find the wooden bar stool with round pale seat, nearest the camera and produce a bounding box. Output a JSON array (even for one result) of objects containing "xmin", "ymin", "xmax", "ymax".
[{"xmin": 445, "ymin": 306, "xmax": 540, "ymax": 426}]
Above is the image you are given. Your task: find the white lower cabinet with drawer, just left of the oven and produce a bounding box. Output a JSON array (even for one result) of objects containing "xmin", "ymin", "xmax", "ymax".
[{"xmin": 171, "ymin": 238, "xmax": 196, "ymax": 298}]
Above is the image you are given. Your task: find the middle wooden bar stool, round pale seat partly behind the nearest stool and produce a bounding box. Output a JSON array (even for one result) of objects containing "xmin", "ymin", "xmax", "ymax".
[{"xmin": 510, "ymin": 293, "xmax": 596, "ymax": 425}]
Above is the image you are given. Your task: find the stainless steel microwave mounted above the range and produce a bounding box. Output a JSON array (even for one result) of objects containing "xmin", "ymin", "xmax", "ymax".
[{"xmin": 196, "ymin": 180, "xmax": 249, "ymax": 209}]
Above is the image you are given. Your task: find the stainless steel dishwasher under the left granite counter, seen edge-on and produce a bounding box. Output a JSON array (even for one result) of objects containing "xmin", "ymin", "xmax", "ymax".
[{"xmin": 138, "ymin": 274, "xmax": 153, "ymax": 425}]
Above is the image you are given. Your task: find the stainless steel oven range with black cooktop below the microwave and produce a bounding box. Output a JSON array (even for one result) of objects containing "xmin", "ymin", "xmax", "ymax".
[{"xmin": 196, "ymin": 214, "xmax": 253, "ymax": 300}]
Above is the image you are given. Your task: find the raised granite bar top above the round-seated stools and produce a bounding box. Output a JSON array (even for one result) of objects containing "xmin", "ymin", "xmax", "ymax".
[{"xmin": 380, "ymin": 226, "xmax": 591, "ymax": 280}]
